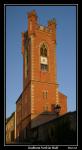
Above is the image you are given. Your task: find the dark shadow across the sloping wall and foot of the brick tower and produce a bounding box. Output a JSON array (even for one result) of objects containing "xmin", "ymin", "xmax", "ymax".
[{"xmin": 16, "ymin": 112, "xmax": 77, "ymax": 145}]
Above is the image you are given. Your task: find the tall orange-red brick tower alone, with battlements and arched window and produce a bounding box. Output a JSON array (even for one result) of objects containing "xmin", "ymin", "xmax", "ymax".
[{"xmin": 22, "ymin": 11, "xmax": 58, "ymax": 117}]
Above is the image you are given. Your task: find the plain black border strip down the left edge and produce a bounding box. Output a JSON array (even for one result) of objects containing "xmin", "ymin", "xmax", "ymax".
[{"xmin": 0, "ymin": 5, "xmax": 4, "ymax": 147}]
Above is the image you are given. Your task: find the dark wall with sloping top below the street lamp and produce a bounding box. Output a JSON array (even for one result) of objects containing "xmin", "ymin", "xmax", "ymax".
[{"xmin": 30, "ymin": 112, "xmax": 77, "ymax": 145}]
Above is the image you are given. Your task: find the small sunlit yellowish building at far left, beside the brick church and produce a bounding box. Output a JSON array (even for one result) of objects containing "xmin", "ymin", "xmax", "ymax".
[{"xmin": 6, "ymin": 112, "xmax": 16, "ymax": 144}]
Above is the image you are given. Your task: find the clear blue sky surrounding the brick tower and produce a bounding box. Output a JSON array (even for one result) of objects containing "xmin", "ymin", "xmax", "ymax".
[{"xmin": 5, "ymin": 5, "xmax": 76, "ymax": 117}]
